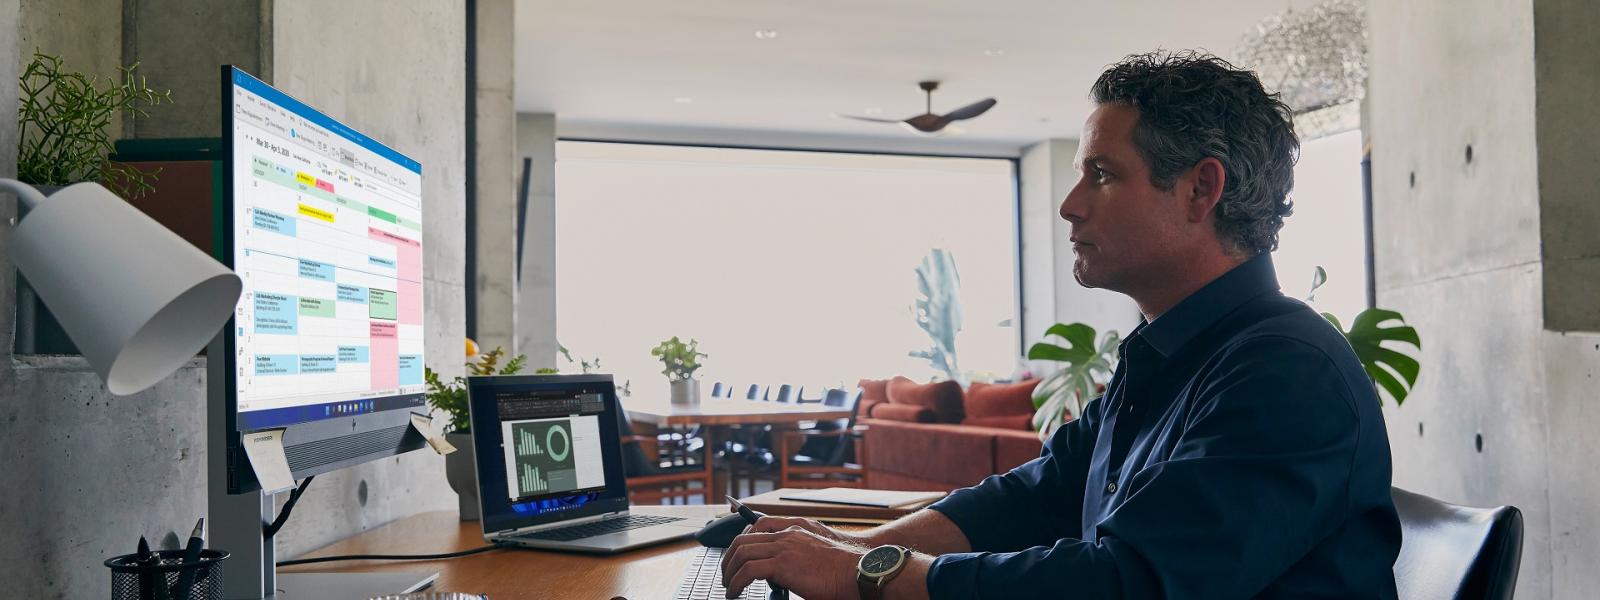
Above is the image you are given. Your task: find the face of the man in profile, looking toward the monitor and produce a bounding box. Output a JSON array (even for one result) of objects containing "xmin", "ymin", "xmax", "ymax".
[{"xmin": 1061, "ymin": 104, "xmax": 1194, "ymax": 294}]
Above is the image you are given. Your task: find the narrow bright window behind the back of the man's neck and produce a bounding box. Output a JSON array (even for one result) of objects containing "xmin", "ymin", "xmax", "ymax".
[{"xmin": 1272, "ymin": 131, "xmax": 1366, "ymax": 328}]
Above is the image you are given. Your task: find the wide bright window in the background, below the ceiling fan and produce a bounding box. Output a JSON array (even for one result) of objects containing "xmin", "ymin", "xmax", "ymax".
[{"xmin": 555, "ymin": 141, "xmax": 1018, "ymax": 397}]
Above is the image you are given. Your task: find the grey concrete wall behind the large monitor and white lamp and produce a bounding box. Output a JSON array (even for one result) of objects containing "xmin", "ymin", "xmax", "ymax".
[{"xmin": 0, "ymin": 0, "xmax": 466, "ymax": 598}]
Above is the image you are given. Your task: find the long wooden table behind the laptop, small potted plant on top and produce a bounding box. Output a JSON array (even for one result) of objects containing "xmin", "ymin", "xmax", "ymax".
[{"xmin": 622, "ymin": 397, "xmax": 850, "ymax": 496}]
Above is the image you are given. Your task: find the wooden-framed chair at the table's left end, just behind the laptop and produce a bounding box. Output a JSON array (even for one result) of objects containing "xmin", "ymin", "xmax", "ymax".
[{"xmin": 616, "ymin": 406, "xmax": 715, "ymax": 504}]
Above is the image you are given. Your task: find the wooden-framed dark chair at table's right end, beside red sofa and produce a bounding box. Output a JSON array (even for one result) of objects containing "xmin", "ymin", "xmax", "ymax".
[{"xmin": 776, "ymin": 387, "xmax": 867, "ymax": 488}]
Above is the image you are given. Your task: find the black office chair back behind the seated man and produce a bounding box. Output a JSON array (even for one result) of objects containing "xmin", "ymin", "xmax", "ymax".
[{"xmin": 1392, "ymin": 488, "xmax": 1522, "ymax": 600}]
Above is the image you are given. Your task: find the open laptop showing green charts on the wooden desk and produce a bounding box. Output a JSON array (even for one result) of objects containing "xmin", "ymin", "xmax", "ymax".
[{"xmin": 467, "ymin": 374, "xmax": 704, "ymax": 554}]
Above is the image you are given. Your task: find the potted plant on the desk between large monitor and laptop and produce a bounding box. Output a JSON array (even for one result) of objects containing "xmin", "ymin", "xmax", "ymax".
[{"xmin": 422, "ymin": 339, "xmax": 528, "ymax": 522}]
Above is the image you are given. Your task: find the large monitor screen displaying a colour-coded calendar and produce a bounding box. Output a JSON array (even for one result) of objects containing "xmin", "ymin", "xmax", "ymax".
[{"xmin": 224, "ymin": 69, "xmax": 426, "ymax": 430}]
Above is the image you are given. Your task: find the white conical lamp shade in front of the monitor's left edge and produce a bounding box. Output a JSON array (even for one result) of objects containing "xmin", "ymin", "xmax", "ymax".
[{"xmin": 11, "ymin": 182, "xmax": 242, "ymax": 395}]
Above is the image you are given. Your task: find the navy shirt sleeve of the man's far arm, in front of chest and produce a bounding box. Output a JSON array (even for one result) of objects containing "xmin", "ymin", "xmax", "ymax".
[{"xmin": 930, "ymin": 398, "xmax": 1101, "ymax": 552}]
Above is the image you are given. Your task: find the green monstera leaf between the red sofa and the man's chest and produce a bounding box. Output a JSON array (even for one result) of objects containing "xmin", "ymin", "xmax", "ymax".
[{"xmin": 1027, "ymin": 323, "xmax": 1122, "ymax": 438}]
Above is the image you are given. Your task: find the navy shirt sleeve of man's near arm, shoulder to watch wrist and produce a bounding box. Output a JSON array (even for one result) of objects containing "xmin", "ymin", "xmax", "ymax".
[{"xmin": 928, "ymin": 338, "xmax": 1358, "ymax": 598}]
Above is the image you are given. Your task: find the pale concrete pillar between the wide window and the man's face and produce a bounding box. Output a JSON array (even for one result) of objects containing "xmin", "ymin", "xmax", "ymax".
[{"xmin": 1019, "ymin": 139, "xmax": 1139, "ymax": 349}]
